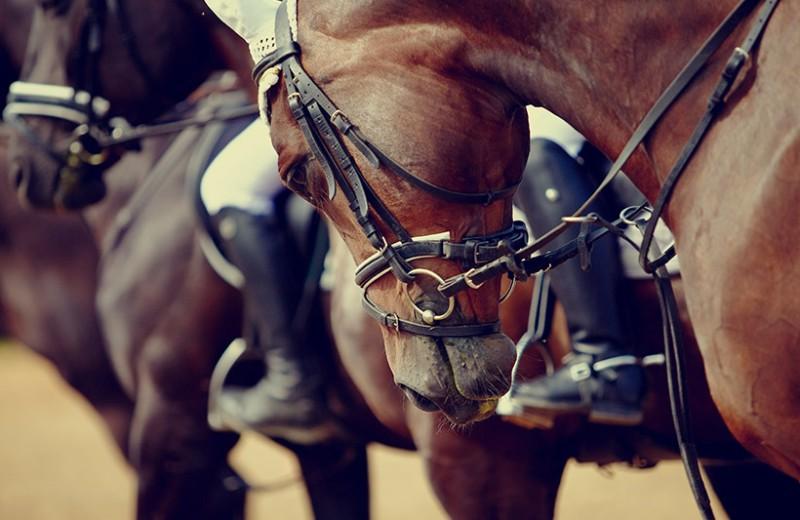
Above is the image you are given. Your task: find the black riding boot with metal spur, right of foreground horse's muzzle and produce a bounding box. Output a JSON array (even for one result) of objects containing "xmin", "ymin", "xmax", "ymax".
[{"xmin": 514, "ymin": 139, "xmax": 645, "ymax": 424}]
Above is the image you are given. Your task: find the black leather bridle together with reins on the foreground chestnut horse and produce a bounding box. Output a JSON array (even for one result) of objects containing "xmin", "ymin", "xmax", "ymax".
[{"xmin": 254, "ymin": 0, "xmax": 779, "ymax": 518}]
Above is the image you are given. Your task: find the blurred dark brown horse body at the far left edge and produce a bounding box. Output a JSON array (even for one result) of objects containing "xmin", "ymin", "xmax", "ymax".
[{"xmin": 0, "ymin": 129, "xmax": 133, "ymax": 453}]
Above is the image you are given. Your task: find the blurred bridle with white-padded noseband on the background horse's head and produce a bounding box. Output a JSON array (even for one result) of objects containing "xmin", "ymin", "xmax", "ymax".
[{"xmin": 3, "ymin": 0, "xmax": 258, "ymax": 207}]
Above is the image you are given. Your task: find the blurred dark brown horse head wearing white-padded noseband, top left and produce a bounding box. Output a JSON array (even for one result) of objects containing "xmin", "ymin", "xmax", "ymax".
[{"xmin": 9, "ymin": 0, "xmax": 244, "ymax": 209}]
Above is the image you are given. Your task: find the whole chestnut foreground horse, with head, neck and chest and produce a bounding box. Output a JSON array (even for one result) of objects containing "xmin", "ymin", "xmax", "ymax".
[{"xmin": 262, "ymin": 0, "xmax": 800, "ymax": 477}]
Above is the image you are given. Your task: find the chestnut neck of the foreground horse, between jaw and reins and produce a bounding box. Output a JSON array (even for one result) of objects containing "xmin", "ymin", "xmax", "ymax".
[{"xmin": 493, "ymin": 0, "xmax": 735, "ymax": 200}]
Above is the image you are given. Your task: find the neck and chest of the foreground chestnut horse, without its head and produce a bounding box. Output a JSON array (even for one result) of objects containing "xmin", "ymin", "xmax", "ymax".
[{"xmin": 490, "ymin": 2, "xmax": 800, "ymax": 477}]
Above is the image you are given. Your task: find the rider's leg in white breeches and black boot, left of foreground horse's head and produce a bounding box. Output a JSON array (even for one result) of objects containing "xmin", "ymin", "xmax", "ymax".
[{"xmin": 201, "ymin": 121, "xmax": 332, "ymax": 442}]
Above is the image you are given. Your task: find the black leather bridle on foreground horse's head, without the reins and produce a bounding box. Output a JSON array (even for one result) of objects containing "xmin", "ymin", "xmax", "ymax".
[{"xmin": 260, "ymin": 2, "xmax": 528, "ymax": 337}]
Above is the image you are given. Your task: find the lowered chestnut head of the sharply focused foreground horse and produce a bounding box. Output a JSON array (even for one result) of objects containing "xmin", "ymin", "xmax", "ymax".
[{"xmin": 262, "ymin": 1, "xmax": 528, "ymax": 423}]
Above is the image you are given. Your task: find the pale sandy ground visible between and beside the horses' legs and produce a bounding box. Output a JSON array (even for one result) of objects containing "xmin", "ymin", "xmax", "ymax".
[{"xmin": 0, "ymin": 345, "xmax": 719, "ymax": 520}]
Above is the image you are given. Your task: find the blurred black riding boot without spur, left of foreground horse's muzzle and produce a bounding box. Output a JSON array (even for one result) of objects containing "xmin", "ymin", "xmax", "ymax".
[{"xmin": 211, "ymin": 208, "xmax": 335, "ymax": 444}]
